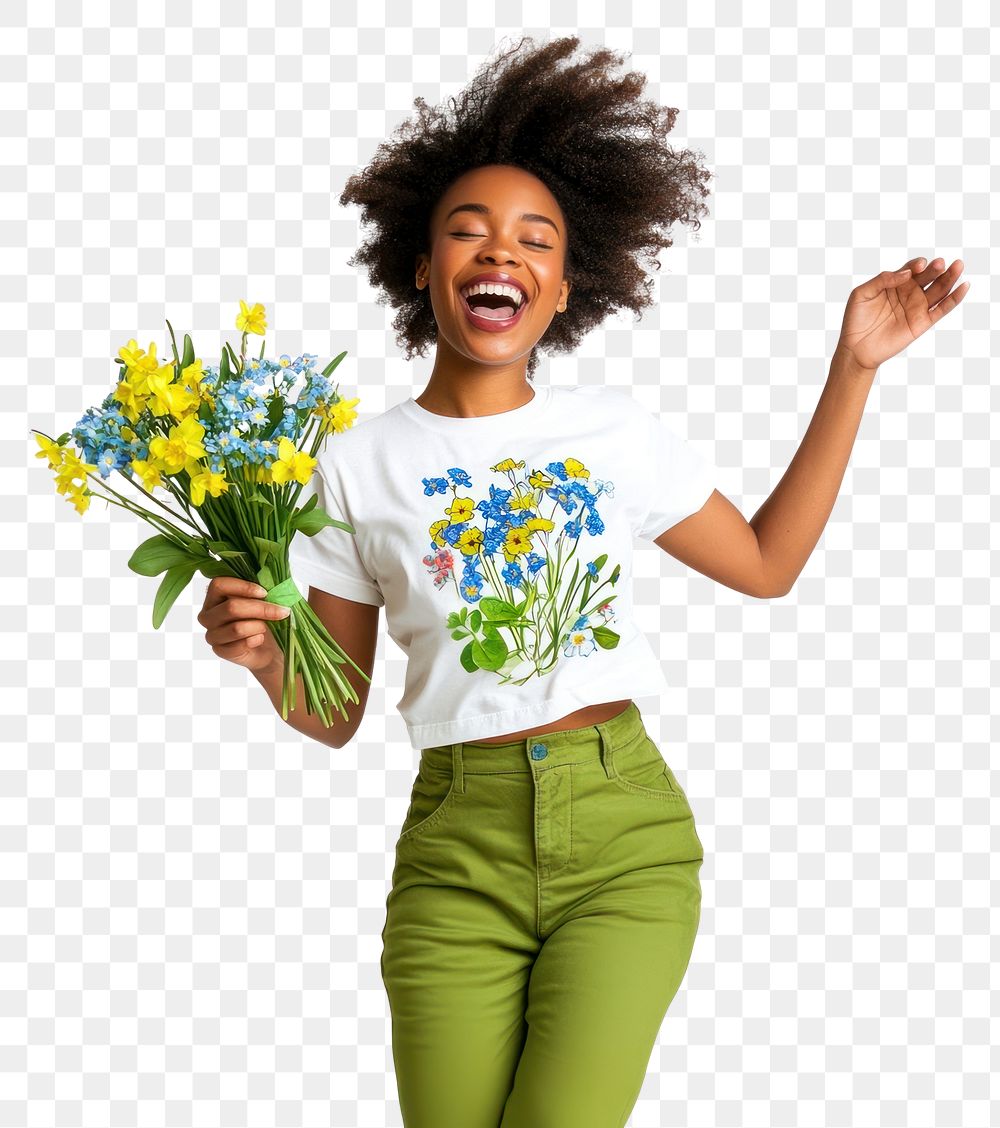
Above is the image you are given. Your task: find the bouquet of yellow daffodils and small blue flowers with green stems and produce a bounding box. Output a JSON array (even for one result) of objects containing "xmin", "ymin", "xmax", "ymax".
[{"xmin": 33, "ymin": 301, "xmax": 369, "ymax": 726}]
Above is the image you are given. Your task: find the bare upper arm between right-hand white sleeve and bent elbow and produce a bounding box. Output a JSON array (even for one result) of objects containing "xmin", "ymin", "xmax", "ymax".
[{"xmin": 654, "ymin": 490, "xmax": 785, "ymax": 599}]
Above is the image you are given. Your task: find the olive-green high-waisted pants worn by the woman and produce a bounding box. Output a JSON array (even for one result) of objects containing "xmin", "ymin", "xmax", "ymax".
[{"xmin": 381, "ymin": 702, "xmax": 703, "ymax": 1128}]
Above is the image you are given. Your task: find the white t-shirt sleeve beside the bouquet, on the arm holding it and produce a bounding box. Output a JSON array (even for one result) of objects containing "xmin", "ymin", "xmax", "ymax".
[{"xmin": 289, "ymin": 466, "xmax": 386, "ymax": 607}]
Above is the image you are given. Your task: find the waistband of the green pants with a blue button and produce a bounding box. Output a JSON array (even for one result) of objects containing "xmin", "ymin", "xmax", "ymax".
[{"xmin": 421, "ymin": 702, "xmax": 646, "ymax": 775}]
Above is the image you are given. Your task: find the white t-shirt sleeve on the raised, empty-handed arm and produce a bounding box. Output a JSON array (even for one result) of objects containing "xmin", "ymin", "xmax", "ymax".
[{"xmin": 635, "ymin": 413, "xmax": 717, "ymax": 540}]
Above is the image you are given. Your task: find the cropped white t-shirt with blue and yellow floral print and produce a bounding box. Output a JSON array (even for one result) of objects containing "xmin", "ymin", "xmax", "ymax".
[{"xmin": 285, "ymin": 386, "xmax": 715, "ymax": 750}]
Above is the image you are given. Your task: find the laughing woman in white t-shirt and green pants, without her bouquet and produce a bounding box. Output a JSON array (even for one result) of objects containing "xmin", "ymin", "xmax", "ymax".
[{"xmin": 201, "ymin": 38, "xmax": 967, "ymax": 1128}]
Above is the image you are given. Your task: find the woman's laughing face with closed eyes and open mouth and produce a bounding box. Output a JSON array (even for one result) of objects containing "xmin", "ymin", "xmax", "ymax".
[{"xmin": 416, "ymin": 165, "xmax": 570, "ymax": 367}]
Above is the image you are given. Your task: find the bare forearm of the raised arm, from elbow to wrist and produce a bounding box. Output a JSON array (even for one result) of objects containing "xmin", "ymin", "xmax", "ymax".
[{"xmin": 749, "ymin": 350, "xmax": 877, "ymax": 596}]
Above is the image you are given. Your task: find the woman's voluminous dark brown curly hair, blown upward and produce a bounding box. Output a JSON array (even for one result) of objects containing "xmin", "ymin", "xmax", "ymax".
[{"xmin": 340, "ymin": 36, "xmax": 711, "ymax": 379}]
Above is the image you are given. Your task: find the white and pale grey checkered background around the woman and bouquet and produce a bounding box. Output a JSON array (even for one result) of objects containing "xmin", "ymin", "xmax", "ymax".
[{"xmin": 0, "ymin": 0, "xmax": 1000, "ymax": 1128}]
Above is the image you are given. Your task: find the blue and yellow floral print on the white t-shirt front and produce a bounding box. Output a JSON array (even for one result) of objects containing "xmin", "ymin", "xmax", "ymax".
[{"xmin": 423, "ymin": 458, "xmax": 621, "ymax": 686}]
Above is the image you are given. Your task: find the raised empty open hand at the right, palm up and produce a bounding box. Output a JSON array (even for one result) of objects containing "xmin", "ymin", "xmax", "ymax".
[{"xmin": 838, "ymin": 258, "xmax": 970, "ymax": 369}]
